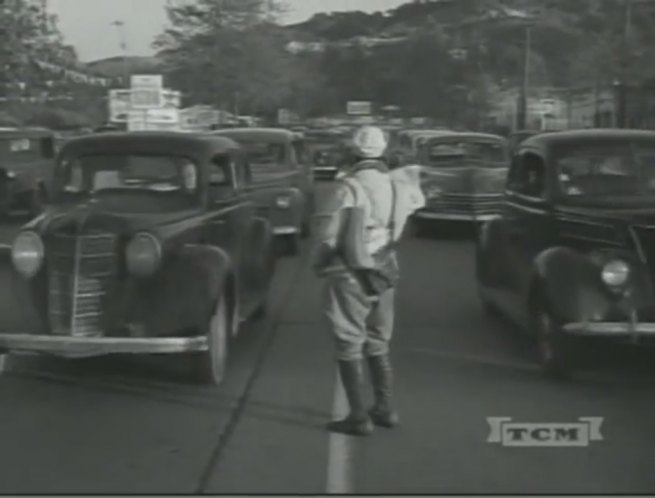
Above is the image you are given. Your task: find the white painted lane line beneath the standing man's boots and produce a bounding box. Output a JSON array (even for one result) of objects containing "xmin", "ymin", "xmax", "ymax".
[{"xmin": 326, "ymin": 371, "xmax": 354, "ymax": 494}]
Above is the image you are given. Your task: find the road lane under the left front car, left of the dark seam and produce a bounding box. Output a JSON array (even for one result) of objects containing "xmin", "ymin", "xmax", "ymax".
[{"xmin": 0, "ymin": 249, "xmax": 302, "ymax": 494}]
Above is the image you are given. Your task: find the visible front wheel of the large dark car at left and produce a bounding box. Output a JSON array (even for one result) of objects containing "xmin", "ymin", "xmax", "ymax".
[{"xmin": 199, "ymin": 297, "xmax": 230, "ymax": 386}]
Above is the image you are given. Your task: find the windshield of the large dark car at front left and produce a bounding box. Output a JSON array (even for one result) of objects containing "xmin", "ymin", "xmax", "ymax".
[{"xmin": 59, "ymin": 154, "xmax": 198, "ymax": 194}]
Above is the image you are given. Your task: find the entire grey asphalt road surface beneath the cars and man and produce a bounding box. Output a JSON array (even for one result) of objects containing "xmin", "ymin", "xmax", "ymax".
[{"xmin": 0, "ymin": 196, "xmax": 655, "ymax": 494}]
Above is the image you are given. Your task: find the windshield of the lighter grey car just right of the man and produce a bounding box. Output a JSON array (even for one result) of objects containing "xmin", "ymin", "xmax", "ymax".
[{"xmin": 427, "ymin": 140, "xmax": 507, "ymax": 166}]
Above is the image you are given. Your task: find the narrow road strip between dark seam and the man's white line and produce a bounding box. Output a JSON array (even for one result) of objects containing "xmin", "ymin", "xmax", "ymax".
[{"xmin": 207, "ymin": 182, "xmax": 346, "ymax": 494}]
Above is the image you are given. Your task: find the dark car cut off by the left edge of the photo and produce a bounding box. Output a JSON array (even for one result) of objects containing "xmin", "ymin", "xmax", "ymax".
[{"xmin": 0, "ymin": 128, "xmax": 55, "ymax": 216}]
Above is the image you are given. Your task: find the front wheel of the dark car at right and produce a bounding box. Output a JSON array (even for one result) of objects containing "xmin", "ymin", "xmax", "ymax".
[{"xmin": 532, "ymin": 304, "xmax": 572, "ymax": 380}]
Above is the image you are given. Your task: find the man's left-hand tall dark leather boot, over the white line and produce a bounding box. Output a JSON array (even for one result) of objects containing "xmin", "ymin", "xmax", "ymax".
[{"xmin": 327, "ymin": 360, "xmax": 373, "ymax": 436}]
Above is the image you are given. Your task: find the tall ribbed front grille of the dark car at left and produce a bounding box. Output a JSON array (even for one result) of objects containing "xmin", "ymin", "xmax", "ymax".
[{"xmin": 46, "ymin": 233, "xmax": 117, "ymax": 337}]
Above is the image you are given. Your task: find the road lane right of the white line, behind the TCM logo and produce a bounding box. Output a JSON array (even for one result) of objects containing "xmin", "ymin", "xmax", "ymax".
[{"xmin": 353, "ymin": 239, "xmax": 655, "ymax": 494}]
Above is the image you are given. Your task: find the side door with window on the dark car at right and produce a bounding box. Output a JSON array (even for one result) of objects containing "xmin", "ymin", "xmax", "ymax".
[{"xmin": 503, "ymin": 150, "xmax": 553, "ymax": 299}]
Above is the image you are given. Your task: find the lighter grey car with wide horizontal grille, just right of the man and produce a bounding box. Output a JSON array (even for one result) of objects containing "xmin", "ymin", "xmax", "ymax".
[{"xmin": 414, "ymin": 132, "xmax": 510, "ymax": 234}]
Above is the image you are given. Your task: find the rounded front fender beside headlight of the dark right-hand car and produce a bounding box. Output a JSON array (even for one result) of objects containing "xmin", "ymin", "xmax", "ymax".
[{"xmin": 527, "ymin": 247, "xmax": 652, "ymax": 322}]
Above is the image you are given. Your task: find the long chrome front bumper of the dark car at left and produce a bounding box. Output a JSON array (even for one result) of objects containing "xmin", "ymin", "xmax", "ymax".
[{"xmin": 0, "ymin": 334, "xmax": 209, "ymax": 357}]
